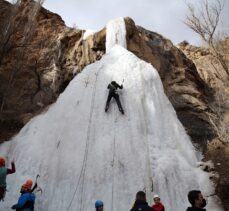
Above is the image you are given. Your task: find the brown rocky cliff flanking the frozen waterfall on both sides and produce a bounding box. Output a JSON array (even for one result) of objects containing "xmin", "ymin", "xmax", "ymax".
[{"xmin": 0, "ymin": 0, "xmax": 229, "ymax": 210}]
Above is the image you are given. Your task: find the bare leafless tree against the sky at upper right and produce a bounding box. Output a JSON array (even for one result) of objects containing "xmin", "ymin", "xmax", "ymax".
[{"xmin": 184, "ymin": 0, "xmax": 229, "ymax": 74}]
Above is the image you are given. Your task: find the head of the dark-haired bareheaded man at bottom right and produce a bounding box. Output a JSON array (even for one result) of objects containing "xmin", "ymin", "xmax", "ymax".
[{"xmin": 188, "ymin": 190, "xmax": 206, "ymax": 208}]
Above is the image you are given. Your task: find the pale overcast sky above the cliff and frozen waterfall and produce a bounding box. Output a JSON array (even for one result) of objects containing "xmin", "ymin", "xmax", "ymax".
[{"xmin": 10, "ymin": 0, "xmax": 229, "ymax": 45}]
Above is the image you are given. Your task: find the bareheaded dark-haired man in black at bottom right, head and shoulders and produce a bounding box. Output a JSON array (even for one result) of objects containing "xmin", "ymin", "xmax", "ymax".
[{"xmin": 186, "ymin": 190, "xmax": 206, "ymax": 211}]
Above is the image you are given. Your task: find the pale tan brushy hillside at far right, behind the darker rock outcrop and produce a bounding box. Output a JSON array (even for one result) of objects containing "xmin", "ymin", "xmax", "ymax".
[{"xmin": 178, "ymin": 39, "xmax": 229, "ymax": 210}]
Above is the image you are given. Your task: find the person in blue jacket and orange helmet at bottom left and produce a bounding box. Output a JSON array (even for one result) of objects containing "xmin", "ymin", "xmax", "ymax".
[{"xmin": 11, "ymin": 180, "xmax": 35, "ymax": 211}]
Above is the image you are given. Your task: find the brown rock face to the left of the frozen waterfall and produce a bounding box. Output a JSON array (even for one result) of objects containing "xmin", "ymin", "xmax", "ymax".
[{"xmin": 0, "ymin": 0, "xmax": 105, "ymax": 142}]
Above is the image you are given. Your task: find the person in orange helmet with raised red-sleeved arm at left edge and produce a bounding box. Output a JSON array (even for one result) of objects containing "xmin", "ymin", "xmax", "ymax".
[{"xmin": 0, "ymin": 157, "xmax": 16, "ymax": 201}]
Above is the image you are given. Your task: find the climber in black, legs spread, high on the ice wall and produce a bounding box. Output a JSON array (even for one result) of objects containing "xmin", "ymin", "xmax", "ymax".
[{"xmin": 105, "ymin": 81, "xmax": 124, "ymax": 114}]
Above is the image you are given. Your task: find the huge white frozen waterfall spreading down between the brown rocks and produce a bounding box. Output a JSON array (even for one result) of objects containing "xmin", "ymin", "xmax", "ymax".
[{"xmin": 0, "ymin": 19, "xmax": 221, "ymax": 211}]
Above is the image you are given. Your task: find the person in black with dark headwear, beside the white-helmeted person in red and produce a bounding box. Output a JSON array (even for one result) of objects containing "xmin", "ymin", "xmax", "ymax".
[{"xmin": 130, "ymin": 191, "xmax": 152, "ymax": 211}]
